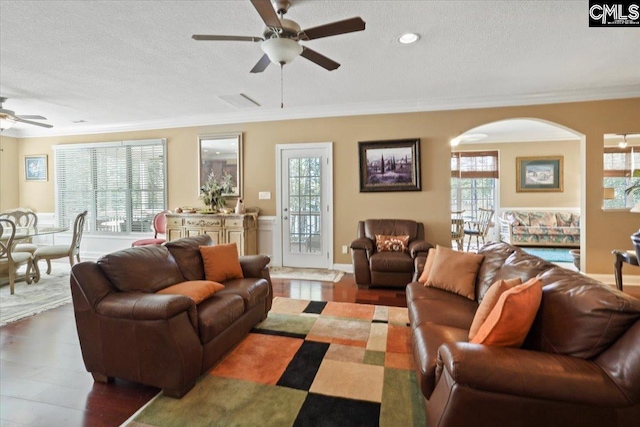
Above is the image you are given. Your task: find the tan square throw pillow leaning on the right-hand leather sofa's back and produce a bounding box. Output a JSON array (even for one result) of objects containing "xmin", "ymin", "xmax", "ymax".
[{"xmin": 425, "ymin": 245, "xmax": 484, "ymax": 299}]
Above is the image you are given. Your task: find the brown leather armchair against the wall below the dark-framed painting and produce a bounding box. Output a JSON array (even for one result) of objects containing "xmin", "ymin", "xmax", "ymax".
[{"xmin": 351, "ymin": 219, "xmax": 433, "ymax": 288}]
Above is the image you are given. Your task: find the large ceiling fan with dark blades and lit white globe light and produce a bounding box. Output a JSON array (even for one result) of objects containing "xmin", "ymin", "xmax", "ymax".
[{"xmin": 192, "ymin": 0, "xmax": 365, "ymax": 73}]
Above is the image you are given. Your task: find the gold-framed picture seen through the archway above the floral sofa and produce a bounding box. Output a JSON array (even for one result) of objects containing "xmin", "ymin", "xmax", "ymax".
[{"xmin": 516, "ymin": 156, "xmax": 564, "ymax": 193}]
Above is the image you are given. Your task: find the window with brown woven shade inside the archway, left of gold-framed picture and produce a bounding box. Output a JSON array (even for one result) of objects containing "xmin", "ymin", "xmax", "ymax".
[{"xmin": 451, "ymin": 151, "xmax": 500, "ymax": 220}]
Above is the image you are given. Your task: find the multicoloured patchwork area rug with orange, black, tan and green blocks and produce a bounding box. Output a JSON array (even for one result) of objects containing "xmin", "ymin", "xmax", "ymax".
[{"xmin": 125, "ymin": 298, "xmax": 426, "ymax": 427}]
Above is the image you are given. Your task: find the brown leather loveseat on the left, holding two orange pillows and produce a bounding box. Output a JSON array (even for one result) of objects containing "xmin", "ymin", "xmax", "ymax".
[{"xmin": 71, "ymin": 235, "xmax": 273, "ymax": 397}]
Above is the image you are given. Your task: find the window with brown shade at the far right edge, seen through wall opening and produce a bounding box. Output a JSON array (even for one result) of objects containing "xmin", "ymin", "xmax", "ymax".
[{"xmin": 603, "ymin": 147, "xmax": 640, "ymax": 209}]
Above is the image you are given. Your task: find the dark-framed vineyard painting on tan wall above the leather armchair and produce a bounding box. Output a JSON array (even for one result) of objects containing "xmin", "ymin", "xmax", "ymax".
[{"xmin": 358, "ymin": 139, "xmax": 421, "ymax": 193}]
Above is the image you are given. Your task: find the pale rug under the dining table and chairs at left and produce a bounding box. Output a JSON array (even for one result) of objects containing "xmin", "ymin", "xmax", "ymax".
[{"xmin": 0, "ymin": 262, "xmax": 71, "ymax": 326}]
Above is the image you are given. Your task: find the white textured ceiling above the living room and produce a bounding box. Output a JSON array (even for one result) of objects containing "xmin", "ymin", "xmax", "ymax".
[{"xmin": 0, "ymin": 0, "xmax": 640, "ymax": 136}]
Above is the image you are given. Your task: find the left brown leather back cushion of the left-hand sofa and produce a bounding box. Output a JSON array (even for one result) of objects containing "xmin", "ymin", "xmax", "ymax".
[{"xmin": 98, "ymin": 245, "xmax": 184, "ymax": 292}]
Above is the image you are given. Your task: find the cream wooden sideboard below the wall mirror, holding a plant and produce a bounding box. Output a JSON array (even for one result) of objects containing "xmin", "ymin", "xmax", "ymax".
[{"xmin": 167, "ymin": 213, "xmax": 258, "ymax": 255}]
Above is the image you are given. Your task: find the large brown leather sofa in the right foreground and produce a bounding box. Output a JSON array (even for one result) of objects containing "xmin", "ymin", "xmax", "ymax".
[{"xmin": 407, "ymin": 243, "xmax": 640, "ymax": 427}]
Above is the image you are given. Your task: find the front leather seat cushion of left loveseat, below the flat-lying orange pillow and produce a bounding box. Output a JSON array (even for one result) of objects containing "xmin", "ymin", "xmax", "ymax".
[{"xmin": 198, "ymin": 291, "xmax": 245, "ymax": 344}]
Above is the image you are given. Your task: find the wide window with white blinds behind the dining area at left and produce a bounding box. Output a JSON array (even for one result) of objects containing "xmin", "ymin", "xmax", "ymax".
[{"xmin": 54, "ymin": 139, "xmax": 167, "ymax": 233}]
